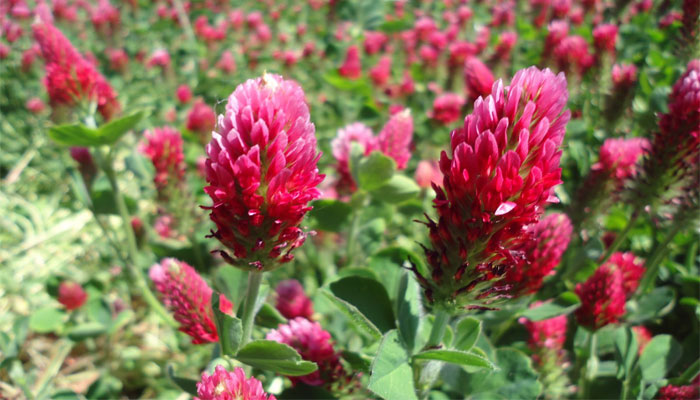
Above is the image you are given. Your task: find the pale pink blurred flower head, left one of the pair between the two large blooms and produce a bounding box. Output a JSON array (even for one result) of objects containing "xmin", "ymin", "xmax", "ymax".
[{"xmin": 331, "ymin": 122, "xmax": 378, "ymax": 191}]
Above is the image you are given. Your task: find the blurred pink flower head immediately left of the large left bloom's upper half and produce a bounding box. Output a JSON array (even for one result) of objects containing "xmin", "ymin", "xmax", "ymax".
[{"xmin": 139, "ymin": 126, "xmax": 185, "ymax": 201}]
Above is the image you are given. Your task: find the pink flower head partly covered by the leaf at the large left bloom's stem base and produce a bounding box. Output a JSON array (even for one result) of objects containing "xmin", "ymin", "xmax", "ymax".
[{"xmin": 265, "ymin": 317, "xmax": 345, "ymax": 387}]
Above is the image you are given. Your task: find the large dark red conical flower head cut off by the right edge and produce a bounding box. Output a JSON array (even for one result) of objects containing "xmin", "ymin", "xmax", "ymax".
[{"xmin": 630, "ymin": 59, "xmax": 700, "ymax": 208}]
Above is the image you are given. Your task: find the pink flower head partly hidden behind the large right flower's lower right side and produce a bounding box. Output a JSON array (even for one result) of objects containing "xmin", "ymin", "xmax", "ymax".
[{"xmin": 503, "ymin": 213, "xmax": 573, "ymax": 297}]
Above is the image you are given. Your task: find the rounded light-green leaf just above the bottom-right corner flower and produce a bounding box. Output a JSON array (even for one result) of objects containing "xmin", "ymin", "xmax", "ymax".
[{"xmin": 639, "ymin": 335, "xmax": 682, "ymax": 382}]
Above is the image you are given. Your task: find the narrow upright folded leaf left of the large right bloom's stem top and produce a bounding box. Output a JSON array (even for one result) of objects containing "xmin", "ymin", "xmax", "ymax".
[{"xmin": 396, "ymin": 271, "xmax": 423, "ymax": 354}]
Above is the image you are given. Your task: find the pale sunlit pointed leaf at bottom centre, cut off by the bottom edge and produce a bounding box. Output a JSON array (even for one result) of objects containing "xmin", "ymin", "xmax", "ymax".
[{"xmin": 368, "ymin": 330, "xmax": 418, "ymax": 400}]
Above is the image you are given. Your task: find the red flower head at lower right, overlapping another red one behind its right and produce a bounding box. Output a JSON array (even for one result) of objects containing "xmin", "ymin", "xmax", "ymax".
[{"xmin": 576, "ymin": 264, "xmax": 625, "ymax": 331}]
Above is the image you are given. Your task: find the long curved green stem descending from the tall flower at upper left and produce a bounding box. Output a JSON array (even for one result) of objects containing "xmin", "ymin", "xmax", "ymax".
[{"xmin": 95, "ymin": 149, "xmax": 177, "ymax": 326}]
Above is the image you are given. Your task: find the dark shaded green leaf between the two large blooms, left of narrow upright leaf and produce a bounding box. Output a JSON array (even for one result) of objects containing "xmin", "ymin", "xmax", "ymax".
[{"xmin": 329, "ymin": 276, "xmax": 396, "ymax": 333}]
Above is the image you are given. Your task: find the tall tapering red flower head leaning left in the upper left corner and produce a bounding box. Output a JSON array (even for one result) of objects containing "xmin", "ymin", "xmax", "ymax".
[{"xmin": 32, "ymin": 23, "xmax": 120, "ymax": 120}]
